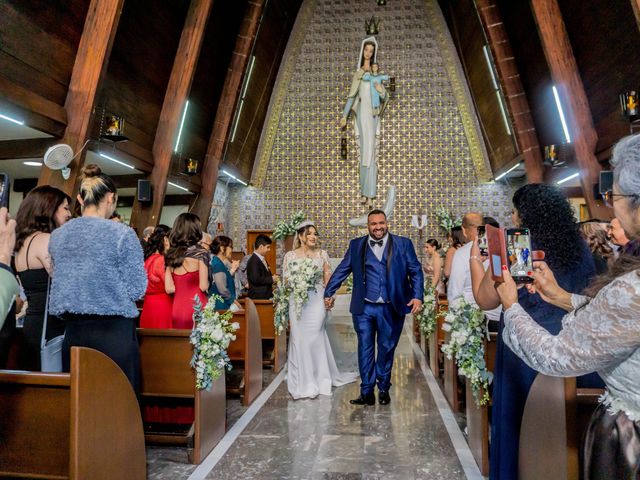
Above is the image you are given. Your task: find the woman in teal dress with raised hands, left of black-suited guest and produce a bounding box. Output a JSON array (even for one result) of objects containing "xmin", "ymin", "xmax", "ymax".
[{"xmin": 209, "ymin": 235, "xmax": 240, "ymax": 310}]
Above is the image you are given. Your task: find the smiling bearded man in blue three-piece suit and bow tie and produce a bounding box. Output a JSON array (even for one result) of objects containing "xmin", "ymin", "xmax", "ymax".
[{"xmin": 324, "ymin": 210, "xmax": 423, "ymax": 405}]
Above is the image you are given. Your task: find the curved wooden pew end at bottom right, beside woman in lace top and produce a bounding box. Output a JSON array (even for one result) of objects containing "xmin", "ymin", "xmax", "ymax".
[{"xmin": 518, "ymin": 374, "xmax": 604, "ymax": 480}]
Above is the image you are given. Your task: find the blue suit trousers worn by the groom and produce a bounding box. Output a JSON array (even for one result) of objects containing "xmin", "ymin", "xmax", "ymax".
[{"xmin": 353, "ymin": 302, "xmax": 404, "ymax": 395}]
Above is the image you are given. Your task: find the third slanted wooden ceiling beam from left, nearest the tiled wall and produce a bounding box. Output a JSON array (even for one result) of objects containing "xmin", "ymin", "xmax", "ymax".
[{"xmin": 192, "ymin": 0, "xmax": 265, "ymax": 229}]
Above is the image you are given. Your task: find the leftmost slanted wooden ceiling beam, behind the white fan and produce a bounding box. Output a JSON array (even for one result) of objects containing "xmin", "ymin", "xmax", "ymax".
[{"xmin": 38, "ymin": 0, "xmax": 124, "ymax": 198}]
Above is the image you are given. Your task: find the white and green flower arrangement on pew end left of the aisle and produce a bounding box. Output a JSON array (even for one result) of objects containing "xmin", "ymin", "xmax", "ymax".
[{"xmin": 190, "ymin": 295, "xmax": 240, "ymax": 390}]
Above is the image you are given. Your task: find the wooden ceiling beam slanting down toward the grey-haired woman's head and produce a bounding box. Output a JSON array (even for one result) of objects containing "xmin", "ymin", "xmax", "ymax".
[{"xmin": 530, "ymin": 0, "xmax": 612, "ymax": 218}]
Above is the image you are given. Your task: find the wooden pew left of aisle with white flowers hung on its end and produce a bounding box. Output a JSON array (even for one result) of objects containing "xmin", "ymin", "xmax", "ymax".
[{"xmin": 138, "ymin": 328, "xmax": 226, "ymax": 464}]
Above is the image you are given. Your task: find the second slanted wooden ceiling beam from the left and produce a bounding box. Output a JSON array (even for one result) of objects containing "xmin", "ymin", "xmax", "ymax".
[{"xmin": 131, "ymin": 0, "xmax": 213, "ymax": 232}]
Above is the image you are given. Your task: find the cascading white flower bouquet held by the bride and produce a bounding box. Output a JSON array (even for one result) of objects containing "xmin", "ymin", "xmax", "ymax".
[{"xmin": 273, "ymin": 258, "xmax": 322, "ymax": 333}]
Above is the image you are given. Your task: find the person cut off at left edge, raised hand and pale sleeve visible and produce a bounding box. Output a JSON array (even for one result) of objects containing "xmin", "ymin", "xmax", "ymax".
[{"xmin": 0, "ymin": 207, "xmax": 20, "ymax": 368}]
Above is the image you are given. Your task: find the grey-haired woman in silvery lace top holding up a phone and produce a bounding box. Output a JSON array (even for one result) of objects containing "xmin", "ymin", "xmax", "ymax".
[{"xmin": 497, "ymin": 135, "xmax": 640, "ymax": 480}]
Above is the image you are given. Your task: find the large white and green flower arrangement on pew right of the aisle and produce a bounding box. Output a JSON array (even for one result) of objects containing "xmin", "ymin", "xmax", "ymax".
[{"xmin": 442, "ymin": 299, "xmax": 493, "ymax": 406}]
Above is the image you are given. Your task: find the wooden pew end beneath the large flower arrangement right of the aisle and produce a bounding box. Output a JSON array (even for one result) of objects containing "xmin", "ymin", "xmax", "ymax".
[{"xmin": 465, "ymin": 333, "xmax": 500, "ymax": 476}]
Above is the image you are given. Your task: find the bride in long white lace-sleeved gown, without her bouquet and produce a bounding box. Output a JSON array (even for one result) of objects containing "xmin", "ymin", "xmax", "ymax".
[{"xmin": 283, "ymin": 221, "xmax": 358, "ymax": 399}]
